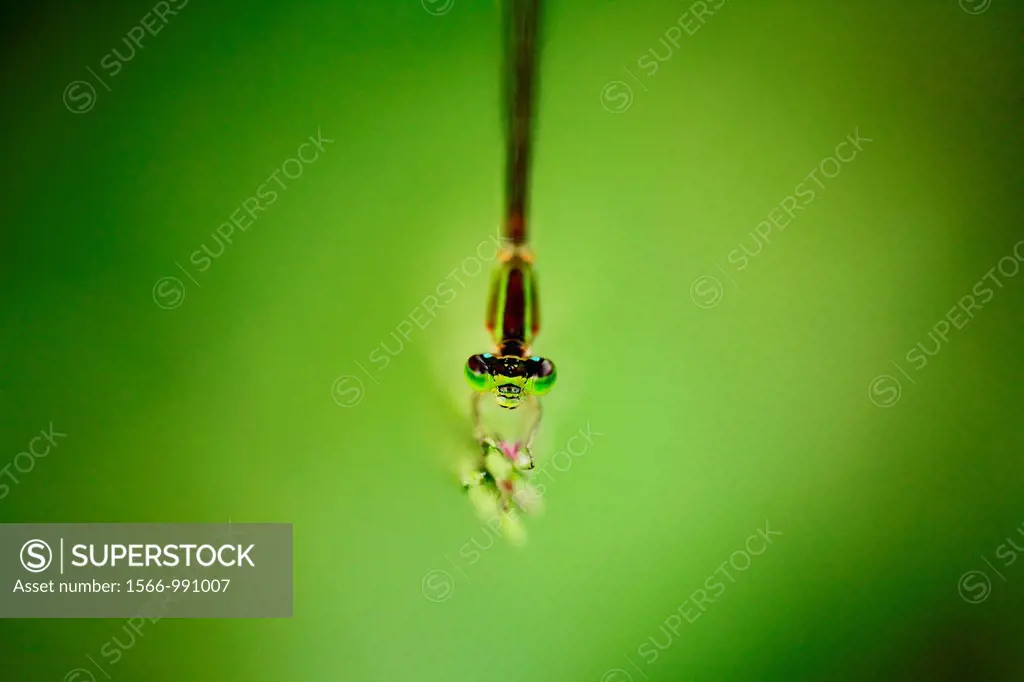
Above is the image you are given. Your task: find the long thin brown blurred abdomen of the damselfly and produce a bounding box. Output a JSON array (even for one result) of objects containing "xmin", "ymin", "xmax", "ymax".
[{"xmin": 505, "ymin": 0, "xmax": 541, "ymax": 245}]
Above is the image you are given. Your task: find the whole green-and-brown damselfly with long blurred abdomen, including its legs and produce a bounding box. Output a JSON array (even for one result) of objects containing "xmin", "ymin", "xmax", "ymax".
[{"xmin": 465, "ymin": 0, "xmax": 557, "ymax": 469}]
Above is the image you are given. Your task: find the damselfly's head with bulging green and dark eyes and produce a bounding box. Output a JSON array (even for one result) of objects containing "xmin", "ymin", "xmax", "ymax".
[{"xmin": 466, "ymin": 353, "xmax": 558, "ymax": 403}]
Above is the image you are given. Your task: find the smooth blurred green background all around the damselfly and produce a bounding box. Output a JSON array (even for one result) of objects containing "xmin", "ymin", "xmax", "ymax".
[{"xmin": 0, "ymin": 0, "xmax": 1024, "ymax": 682}]
